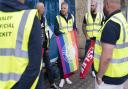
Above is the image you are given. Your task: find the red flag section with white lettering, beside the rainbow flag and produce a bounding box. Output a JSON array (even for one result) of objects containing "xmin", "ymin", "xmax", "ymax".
[{"xmin": 80, "ymin": 40, "xmax": 95, "ymax": 79}]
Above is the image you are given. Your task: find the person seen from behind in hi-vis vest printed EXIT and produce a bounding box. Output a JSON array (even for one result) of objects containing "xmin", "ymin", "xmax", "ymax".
[{"xmin": 0, "ymin": 0, "xmax": 44, "ymax": 89}]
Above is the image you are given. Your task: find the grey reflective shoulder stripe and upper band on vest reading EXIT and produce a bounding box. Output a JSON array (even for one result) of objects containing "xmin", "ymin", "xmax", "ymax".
[{"xmin": 0, "ymin": 10, "xmax": 30, "ymax": 58}]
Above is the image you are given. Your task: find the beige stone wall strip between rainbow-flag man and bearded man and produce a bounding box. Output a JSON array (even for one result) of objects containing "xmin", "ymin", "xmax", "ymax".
[{"xmin": 76, "ymin": 0, "xmax": 87, "ymax": 58}]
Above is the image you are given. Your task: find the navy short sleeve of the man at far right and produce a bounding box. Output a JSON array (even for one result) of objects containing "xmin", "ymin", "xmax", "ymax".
[{"xmin": 101, "ymin": 20, "xmax": 120, "ymax": 45}]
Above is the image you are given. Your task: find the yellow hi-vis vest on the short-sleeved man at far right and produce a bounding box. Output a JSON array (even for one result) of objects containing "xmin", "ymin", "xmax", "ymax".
[{"xmin": 94, "ymin": 13, "xmax": 128, "ymax": 78}]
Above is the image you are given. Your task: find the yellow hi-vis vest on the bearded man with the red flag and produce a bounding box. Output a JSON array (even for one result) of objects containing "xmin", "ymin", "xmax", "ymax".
[{"xmin": 85, "ymin": 12, "xmax": 103, "ymax": 38}]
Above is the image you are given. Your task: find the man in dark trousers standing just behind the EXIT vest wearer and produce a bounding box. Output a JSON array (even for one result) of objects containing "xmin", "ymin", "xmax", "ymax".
[{"xmin": 36, "ymin": 2, "xmax": 59, "ymax": 89}]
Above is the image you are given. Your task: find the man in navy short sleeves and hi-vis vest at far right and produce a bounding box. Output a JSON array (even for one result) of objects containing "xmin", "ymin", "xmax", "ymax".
[{"xmin": 94, "ymin": 0, "xmax": 128, "ymax": 89}]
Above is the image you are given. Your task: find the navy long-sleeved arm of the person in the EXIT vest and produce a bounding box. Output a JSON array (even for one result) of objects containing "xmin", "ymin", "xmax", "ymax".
[{"xmin": 13, "ymin": 17, "xmax": 42, "ymax": 89}]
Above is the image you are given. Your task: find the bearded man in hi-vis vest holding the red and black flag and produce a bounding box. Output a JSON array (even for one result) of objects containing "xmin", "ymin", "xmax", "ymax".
[{"xmin": 82, "ymin": 0, "xmax": 103, "ymax": 77}]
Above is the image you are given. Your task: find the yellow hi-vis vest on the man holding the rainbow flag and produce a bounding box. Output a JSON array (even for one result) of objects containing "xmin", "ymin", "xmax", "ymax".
[{"xmin": 56, "ymin": 15, "xmax": 74, "ymax": 33}]
